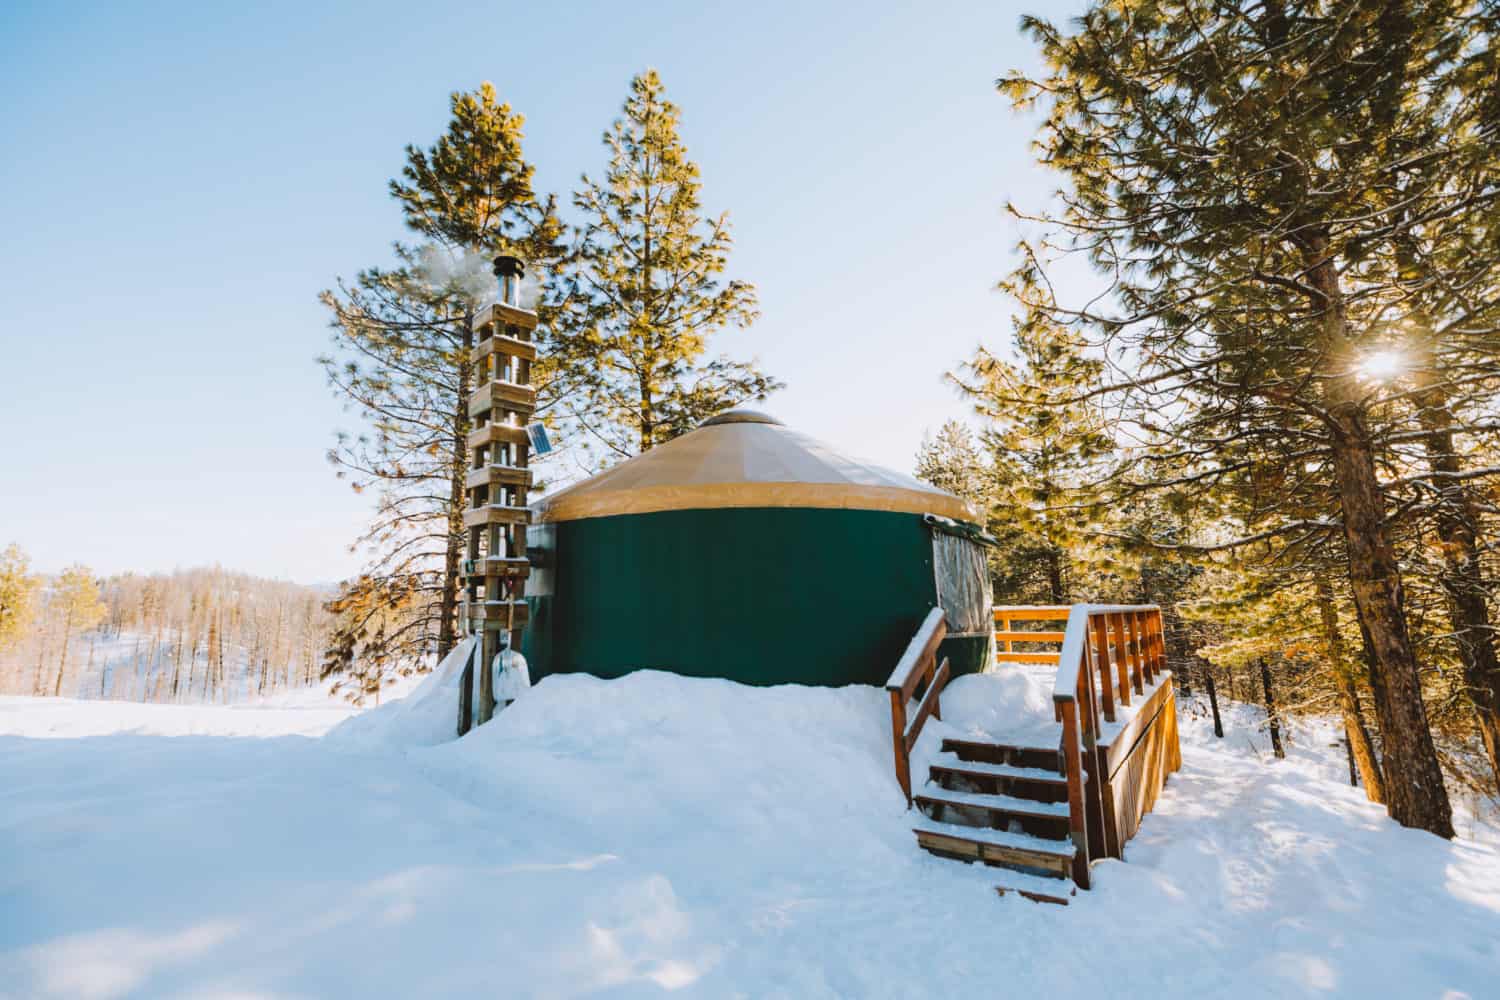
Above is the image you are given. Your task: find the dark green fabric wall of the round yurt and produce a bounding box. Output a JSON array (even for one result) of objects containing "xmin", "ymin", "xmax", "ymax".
[{"xmin": 524, "ymin": 508, "xmax": 981, "ymax": 685}]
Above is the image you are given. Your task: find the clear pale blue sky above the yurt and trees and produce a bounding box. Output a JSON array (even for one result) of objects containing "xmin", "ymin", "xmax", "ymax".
[{"xmin": 0, "ymin": 0, "xmax": 1080, "ymax": 582}]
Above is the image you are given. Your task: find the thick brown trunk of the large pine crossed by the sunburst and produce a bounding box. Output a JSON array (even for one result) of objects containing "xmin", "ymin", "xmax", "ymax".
[{"xmin": 1307, "ymin": 245, "xmax": 1454, "ymax": 838}]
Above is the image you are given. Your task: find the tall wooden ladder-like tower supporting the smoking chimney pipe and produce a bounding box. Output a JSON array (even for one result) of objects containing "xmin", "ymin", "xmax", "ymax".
[{"xmin": 459, "ymin": 255, "xmax": 537, "ymax": 736}]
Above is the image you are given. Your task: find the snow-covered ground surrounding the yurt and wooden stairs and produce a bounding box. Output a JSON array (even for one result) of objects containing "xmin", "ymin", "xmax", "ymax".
[{"xmin": 0, "ymin": 659, "xmax": 1500, "ymax": 999}]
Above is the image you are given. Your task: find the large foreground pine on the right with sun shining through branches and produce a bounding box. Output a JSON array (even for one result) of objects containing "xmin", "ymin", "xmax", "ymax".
[{"xmin": 1002, "ymin": 0, "xmax": 1500, "ymax": 837}]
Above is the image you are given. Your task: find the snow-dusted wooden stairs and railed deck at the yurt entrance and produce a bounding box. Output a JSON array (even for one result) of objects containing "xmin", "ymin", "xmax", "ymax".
[{"xmin": 887, "ymin": 606, "xmax": 1181, "ymax": 906}]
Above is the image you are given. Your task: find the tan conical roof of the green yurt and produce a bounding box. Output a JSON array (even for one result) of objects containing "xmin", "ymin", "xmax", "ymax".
[{"xmin": 536, "ymin": 409, "xmax": 975, "ymax": 522}]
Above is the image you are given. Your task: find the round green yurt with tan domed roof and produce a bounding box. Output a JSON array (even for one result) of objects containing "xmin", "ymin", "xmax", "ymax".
[{"xmin": 524, "ymin": 409, "xmax": 993, "ymax": 685}]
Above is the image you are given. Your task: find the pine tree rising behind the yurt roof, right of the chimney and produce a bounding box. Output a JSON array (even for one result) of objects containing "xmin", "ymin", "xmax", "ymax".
[{"xmin": 548, "ymin": 69, "xmax": 780, "ymax": 460}]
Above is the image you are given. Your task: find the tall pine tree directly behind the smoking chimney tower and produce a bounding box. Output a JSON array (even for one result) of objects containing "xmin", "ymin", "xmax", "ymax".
[{"xmin": 320, "ymin": 82, "xmax": 561, "ymax": 677}]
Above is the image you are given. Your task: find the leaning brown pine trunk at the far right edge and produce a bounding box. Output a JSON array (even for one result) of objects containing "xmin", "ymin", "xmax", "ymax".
[{"xmin": 1416, "ymin": 364, "xmax": 1500, "ymax": 790}]
